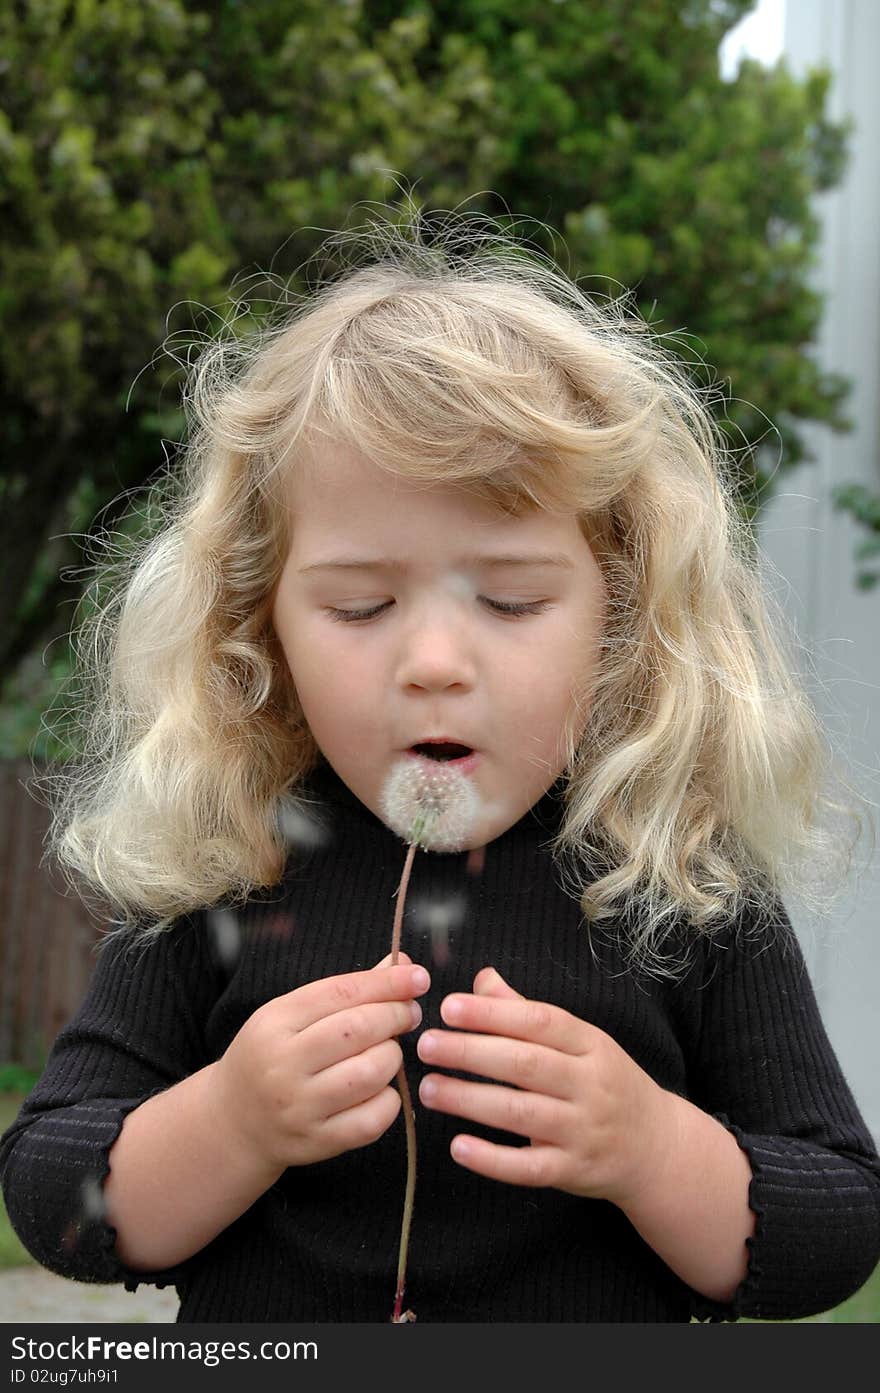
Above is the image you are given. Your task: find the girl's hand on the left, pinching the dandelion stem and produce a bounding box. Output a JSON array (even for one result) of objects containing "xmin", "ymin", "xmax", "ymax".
[{"xmin": 213, "ymin": 953, "xmax": 430, "ymax": 1178}]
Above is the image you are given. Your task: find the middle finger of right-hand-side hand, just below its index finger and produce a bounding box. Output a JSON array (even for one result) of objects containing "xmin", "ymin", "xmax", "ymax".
[{"xmin": 416, "ymin": 1031, "xmax": 578, "ymax": 1099}]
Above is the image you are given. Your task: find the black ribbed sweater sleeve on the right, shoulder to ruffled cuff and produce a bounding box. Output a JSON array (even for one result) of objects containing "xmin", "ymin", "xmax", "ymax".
[{"xmin": 689, "ymin": 903, "xmax": 880, "ymax": 1321}]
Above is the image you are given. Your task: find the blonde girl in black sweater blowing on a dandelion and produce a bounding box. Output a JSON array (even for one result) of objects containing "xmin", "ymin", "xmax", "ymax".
[{"xmin": 1, "ymin": 206, "xmax": 880, "ymax": 1322}]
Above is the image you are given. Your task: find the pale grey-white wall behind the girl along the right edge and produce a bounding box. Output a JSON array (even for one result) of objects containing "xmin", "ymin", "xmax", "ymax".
[{"xmin": 759, "ymin": 0, "xmax": 880, "ymax": 1138}]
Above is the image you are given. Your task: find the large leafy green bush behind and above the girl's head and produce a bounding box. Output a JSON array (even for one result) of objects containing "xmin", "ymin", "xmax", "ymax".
[{"xmin": 0, "ymin": 0, "xmax": 847, "ymax": 759}]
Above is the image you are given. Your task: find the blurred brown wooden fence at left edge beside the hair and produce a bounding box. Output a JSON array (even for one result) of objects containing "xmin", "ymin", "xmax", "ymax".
[{"xmin": 0, "ymin": 759, "xmax": 100, "ymax": 1068}]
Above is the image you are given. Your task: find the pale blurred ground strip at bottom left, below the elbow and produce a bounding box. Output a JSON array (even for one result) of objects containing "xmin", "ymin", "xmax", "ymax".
[{"xmin": 0, "ymin": 1266, "xmax": 180, "ymax": 1325}]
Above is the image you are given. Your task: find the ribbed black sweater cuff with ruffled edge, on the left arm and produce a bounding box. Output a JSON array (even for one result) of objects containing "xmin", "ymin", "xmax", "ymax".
[{"xmin": 4, "ymin": 1085, "xmax": 189, "ymax": 1291}]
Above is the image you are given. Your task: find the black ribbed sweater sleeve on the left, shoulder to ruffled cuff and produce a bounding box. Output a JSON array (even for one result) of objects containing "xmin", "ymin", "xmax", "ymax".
[{"xmin": 0, "ymin": 915, "xmax": 220, "ymax": 1290}]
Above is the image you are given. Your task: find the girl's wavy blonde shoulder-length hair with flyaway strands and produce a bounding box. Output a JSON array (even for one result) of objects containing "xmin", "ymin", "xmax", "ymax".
[{"xmin": 32, "ymin": 206, "xmax": 862, "ymax": 975}]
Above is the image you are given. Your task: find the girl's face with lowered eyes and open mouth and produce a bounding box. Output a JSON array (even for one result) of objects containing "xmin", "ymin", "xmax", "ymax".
[{"xmin": 273, "ymin": 444, "xmax": 604, "ymax": 850}]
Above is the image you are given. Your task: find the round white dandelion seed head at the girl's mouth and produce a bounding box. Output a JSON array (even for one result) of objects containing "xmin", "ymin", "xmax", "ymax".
[{"xmin": 380, "ymin": 759, "xmax": 480, "ymax": 851}]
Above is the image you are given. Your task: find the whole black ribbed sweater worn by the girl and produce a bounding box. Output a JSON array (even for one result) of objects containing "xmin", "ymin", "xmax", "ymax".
[{"xmin": 0, "ymin": 762, "xmax": 880, "ymax": 1322}]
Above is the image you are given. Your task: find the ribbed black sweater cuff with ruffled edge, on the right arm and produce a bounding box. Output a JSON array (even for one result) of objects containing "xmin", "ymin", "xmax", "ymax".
[{"xmin": 693, "ymin": 1113, "xmax": 880, "ymax": 1321}]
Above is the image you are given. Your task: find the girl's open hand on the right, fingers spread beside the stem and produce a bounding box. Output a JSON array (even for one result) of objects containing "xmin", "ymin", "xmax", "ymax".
[{"xmin": 418, "ymin": 968, "xmax": 678, "ymax": 1208}]
